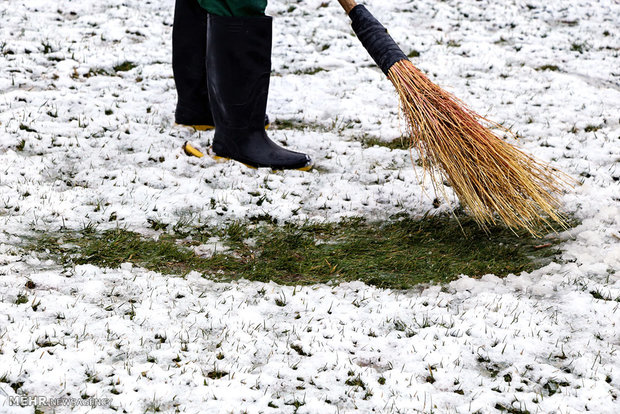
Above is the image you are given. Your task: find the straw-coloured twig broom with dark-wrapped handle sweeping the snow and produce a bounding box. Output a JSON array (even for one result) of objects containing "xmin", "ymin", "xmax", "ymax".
[{"xmin": 338, "ymin": 0, "xmax": 571, "ymax": 237}]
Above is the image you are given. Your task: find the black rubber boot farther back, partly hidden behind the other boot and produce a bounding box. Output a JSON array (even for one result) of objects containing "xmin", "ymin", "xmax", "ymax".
[{"xmin": 172, "ymin": 0, "xmax": 213, "ymax": 128}]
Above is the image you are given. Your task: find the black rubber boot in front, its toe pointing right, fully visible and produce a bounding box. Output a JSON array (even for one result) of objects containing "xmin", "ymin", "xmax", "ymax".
[{"xmin": 207, "ymin": 15, "xmax": 312, "ymax": 170}]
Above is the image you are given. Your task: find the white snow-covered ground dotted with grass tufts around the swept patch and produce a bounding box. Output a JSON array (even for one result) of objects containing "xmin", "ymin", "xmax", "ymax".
[{"xmin": 0, "ymin": 0, "xmax": 620, "ymax": 413}]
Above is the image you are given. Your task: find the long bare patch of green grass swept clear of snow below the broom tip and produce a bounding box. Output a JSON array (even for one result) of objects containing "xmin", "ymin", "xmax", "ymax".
[{"xmin": 26, "ymin": 217, "xmax": 568, "ymax": 290}]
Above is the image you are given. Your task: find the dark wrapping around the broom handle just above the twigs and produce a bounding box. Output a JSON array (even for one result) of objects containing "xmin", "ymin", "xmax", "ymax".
[{"xmin": 349, "ymin": 4, "xmax": 407, "ymax": 75}]
